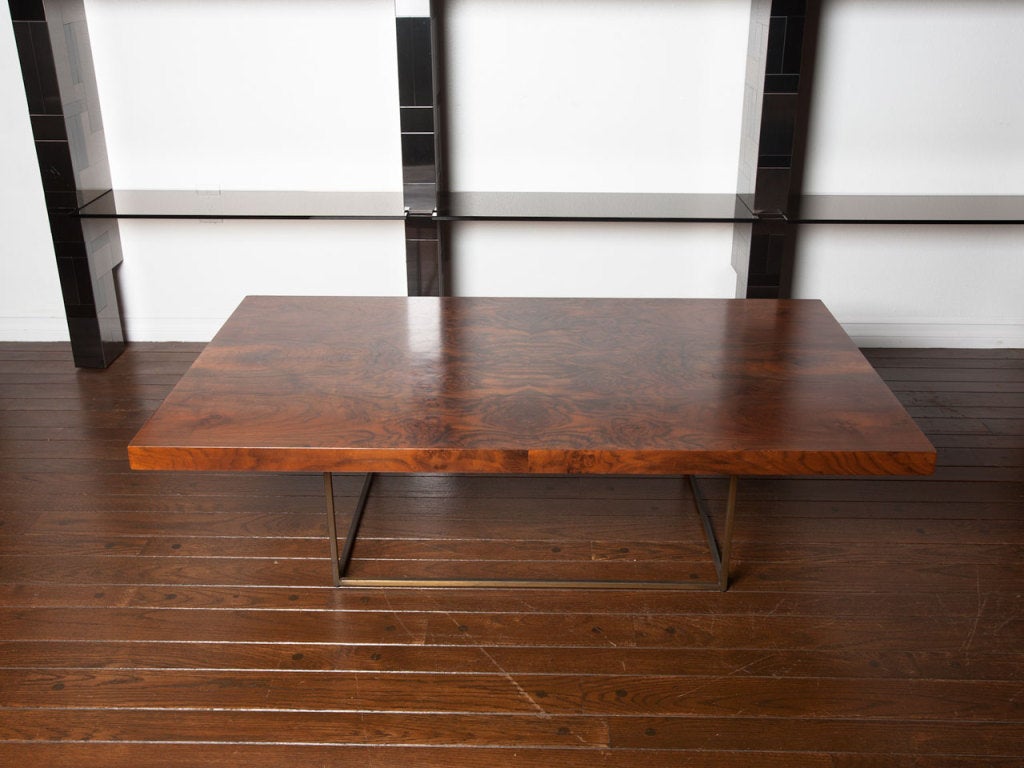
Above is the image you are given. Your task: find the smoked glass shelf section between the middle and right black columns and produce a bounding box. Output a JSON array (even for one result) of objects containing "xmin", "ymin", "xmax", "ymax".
[{"xmin": 437, "ymin": 191, "xmax": 755, "ymax": 221}]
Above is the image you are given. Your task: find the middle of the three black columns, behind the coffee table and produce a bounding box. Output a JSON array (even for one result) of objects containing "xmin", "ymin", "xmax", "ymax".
[{"xmin": 395, "ymin": 0, "xmax": 449, "ymax": 296}]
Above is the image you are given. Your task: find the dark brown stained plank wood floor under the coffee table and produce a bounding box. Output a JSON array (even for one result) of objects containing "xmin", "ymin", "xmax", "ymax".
[{"xmin": 0, "ymin": 344, "xmax": 1024, "ymax": 768}]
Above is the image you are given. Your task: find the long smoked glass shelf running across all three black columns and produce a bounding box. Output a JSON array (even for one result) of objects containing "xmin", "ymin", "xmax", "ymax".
[{"xmin": 78, "ymin": 189, "xmax": 1024, "ymax": 224}]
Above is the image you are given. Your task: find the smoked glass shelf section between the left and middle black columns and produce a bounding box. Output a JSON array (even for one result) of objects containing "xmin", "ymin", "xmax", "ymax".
[{"xmin": 78, "ymin": 189, "xmax": 404, "ymax": 219}]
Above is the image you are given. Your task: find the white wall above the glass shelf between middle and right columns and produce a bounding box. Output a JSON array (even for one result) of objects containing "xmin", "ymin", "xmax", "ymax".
[{"xmin": 445, "ymin": 0, "xmax": 750, "ymax": 193}]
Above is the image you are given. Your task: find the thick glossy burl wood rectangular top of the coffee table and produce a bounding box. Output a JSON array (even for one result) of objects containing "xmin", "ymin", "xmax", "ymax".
[{"xmin": 129, "ymin": 296, "xmax": 935, "ymax": 475}]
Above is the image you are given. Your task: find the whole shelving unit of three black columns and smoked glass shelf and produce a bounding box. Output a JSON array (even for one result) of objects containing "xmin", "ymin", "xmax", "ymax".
[{"xmin": 9, "ymin": 0, "xmax": 1024, "ymax": 367}]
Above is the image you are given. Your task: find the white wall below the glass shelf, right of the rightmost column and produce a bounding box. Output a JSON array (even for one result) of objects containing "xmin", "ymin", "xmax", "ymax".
[{"xmin": 799, "ymin": 224, "xmax": 1024, "ymax": 348}]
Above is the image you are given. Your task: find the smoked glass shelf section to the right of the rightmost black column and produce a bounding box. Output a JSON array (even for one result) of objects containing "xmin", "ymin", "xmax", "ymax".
[{"xmin": 797, "ymin": 195, "xmax": 1024, "ymax": 224}]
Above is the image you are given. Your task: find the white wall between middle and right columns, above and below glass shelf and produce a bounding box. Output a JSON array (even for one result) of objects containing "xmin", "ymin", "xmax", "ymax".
[{"xmin": 446, "ymin": 0, "xmax": 750, "ymax": 297}]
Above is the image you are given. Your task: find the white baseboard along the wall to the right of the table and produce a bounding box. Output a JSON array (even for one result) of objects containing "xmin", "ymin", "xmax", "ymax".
[{"xmin": 842, "ymin": 323, "xmax": 1024, "ymax": 349}]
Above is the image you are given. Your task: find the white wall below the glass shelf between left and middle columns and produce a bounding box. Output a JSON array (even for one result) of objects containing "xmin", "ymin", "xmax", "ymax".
[{"xmin": 120, "ymin": 219, "xmax": 406, "ymax": 341}]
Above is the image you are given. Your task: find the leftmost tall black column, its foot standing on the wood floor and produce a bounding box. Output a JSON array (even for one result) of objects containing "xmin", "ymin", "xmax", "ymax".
[{"xmin": 9, "ymin": 0, "xmax": 125, "ymax": 368}]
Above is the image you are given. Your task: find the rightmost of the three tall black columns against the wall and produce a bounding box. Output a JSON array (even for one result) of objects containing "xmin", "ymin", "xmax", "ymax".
[{"xmin": 746, "ymin": 0, "xmax": 819, "ymax": 298}]
